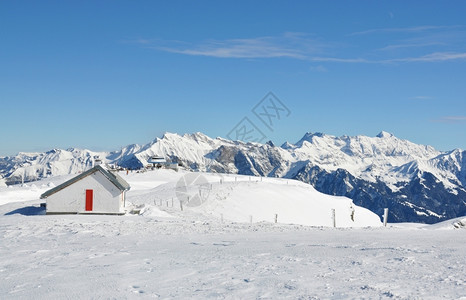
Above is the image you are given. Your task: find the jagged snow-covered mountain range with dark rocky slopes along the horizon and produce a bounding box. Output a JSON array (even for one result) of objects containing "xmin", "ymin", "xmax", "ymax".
[{"xmin": 0, "ymin": 132, "xmax": 466, "ymax": 223}]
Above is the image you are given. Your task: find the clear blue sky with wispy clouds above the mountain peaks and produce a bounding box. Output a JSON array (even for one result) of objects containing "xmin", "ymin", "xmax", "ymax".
[{"xmin": 0, "ymin": 1, "xmax": 466, "ymax": 156}]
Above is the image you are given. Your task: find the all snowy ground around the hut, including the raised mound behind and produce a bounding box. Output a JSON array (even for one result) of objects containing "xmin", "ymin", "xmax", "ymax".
[{"xmin": 0, "ymin": 171, "xmax": 466, "ymax": 299}]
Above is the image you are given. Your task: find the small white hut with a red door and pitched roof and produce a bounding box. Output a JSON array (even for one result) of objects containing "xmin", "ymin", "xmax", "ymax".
[{"xmin": 40, "ymin": 165, "xmax": 130, "ymax": 214}]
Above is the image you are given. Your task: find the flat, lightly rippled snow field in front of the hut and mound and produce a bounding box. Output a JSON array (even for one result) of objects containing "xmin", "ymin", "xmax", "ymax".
[{"xmin": 0, "ymin": 215, "xmax": 466, "ymax": 299}]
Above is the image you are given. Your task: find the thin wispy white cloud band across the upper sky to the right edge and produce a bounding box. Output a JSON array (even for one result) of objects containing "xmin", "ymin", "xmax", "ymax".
[{"xmin": 137, "ymin": 33, "xmax": 466, "ymax": 64}]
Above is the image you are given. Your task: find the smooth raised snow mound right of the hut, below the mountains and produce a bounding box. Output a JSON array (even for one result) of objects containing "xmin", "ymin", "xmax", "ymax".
[{"xmin": 122, "ymin": 170, "xmax": 381, "ymax": 227}]
